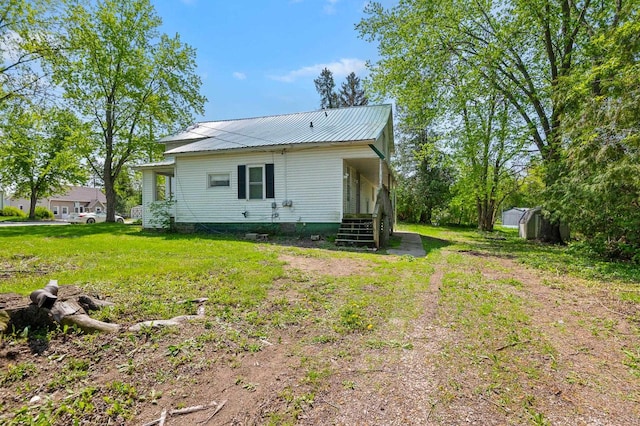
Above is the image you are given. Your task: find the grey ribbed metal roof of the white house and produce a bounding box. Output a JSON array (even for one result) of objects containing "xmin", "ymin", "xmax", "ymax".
[{"xmin": 159, "ymin": 105, "xmax": 391, "ymax": 155}]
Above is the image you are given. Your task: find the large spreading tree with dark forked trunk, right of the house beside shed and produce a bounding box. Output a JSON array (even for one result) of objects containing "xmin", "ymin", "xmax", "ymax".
[{"xmin": 358, "ymin": 0, "xmax": 637, "ymax": 241}]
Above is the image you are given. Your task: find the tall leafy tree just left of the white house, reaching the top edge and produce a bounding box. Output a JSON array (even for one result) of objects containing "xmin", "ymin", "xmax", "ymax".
[{"xmin": 47, "ymin": 0, "xmax": 206, "ymax": 222}]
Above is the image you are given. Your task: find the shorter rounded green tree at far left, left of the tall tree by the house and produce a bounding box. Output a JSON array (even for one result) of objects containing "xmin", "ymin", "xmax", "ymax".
[{"xmin": 0, "ymin": 103, "xmax": 87, "ymax": 219}]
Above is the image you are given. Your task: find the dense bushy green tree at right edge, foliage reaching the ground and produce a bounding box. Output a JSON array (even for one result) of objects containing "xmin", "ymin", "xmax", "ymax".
[{"xmin": 553, "ymin": 19, "xmax": 640, "ymax": 262}]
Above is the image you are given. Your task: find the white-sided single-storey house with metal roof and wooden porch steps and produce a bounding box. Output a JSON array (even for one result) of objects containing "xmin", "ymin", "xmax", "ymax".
[{"xmin": 137, "ymin": 105, "xmax": 395, "ymax": 246}]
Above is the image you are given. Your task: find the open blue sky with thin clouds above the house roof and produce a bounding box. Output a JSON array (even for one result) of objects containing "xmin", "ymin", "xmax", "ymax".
[{"xmin": 152, "ymin": 0, "xmax": 397, "ymax": 121}]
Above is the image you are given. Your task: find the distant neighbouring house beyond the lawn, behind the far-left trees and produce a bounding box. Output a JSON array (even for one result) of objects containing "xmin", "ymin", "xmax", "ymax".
[{"xmin": 7, "ymin": 186, "xmax": 107, "ymax": 219}]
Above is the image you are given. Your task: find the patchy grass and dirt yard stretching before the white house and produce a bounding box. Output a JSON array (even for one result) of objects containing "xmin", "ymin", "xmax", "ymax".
[{"xmin": 0, "ymin": 224, "xmax": 640, "ymax": 425}]
